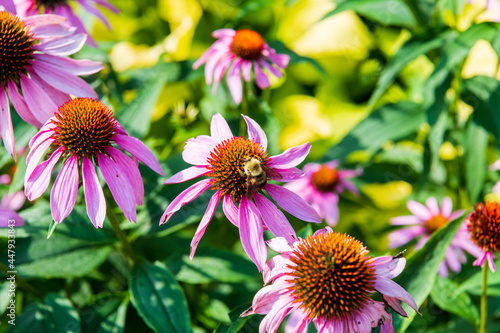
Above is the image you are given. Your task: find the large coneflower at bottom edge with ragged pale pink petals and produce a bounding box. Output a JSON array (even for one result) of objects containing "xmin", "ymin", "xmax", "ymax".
[{"xmin": 242, "ymin": 227, "xmax": 418, "ymax": 333}]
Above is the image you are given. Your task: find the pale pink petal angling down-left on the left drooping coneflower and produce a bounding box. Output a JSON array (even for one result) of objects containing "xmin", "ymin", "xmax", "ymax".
[{"xmin": 24, "ymin": 147, "xmax": 63, "ymax": 201}]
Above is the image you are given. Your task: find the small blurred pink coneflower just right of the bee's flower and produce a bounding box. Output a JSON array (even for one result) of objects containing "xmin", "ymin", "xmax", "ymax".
[{"xmin": 285, "ymin": 160, "xmax": 361, "ymax": 227}]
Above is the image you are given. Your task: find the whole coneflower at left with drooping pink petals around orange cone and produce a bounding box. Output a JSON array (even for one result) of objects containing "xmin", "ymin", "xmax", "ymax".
[{"xmin": 24, "ymin": 98, "xmax": 163, "ymax": 228}]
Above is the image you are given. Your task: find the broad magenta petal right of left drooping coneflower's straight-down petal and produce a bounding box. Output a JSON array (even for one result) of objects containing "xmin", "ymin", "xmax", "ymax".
[{"xmin": 97, "ymin": 153, "xmax": 136, "ymax": 222}]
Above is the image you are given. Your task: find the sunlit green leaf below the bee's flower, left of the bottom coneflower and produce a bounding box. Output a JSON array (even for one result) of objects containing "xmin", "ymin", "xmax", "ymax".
[{"xmin": 166, "ymin": 248, "xmax": 256, "ymax": 284}]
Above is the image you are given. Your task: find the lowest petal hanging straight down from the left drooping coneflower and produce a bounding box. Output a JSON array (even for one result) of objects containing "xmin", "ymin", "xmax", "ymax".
[{"xmin": 82, "ymin": 157, "xmax": 106, "ymax": 228}]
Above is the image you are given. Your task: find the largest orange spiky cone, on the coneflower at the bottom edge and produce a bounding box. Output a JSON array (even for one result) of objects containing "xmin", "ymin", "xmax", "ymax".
[{"xmin": 288, "ymin": 232, "xmax": 375, "ymax": 320}]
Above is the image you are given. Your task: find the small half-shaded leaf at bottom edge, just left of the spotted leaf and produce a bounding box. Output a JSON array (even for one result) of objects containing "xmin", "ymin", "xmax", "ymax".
[{"xmin": 80, "ymin": 295, "xmax": 130, "ymax": 333}]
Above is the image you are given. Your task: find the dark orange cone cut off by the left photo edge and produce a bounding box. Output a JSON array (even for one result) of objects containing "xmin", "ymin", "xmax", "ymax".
[{"xmin": 0, "ymin": 11, "xmax": 36, "ymax": 88}]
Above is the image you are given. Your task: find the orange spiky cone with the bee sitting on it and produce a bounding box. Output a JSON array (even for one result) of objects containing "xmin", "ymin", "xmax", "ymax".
[{"xmin": 207, "ymin": 136, "xmax": 269, "ymax": 203}]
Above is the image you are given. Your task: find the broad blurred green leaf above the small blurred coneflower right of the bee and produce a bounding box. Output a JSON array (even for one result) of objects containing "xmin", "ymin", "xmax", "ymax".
[{"xmin": 323, "ymin": 102, "xmax": 425, "ymax": 161}]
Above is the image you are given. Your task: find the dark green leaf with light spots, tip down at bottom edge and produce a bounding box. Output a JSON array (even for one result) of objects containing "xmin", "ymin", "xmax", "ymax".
[{"xmin": 129, "ymin": 262, "xmax": 191, "ymax": 333}]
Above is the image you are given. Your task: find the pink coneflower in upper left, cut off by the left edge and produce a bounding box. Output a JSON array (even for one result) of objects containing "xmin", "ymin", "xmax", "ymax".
[{"xmin": 0, "ymin": 11, "xmax": 103, "ymax": 158}]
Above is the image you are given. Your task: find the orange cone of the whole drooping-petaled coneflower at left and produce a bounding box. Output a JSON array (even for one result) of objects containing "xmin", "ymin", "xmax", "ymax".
[{"xmin": 52, "ymin": 98, "xmax": 116, "ymax": 159}]
